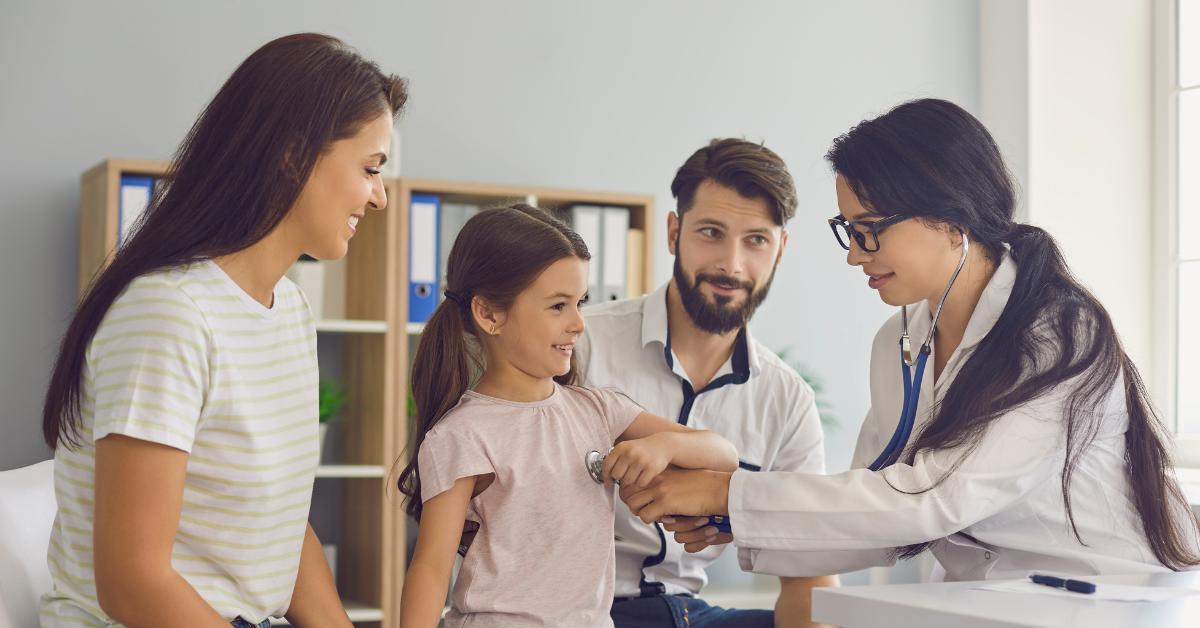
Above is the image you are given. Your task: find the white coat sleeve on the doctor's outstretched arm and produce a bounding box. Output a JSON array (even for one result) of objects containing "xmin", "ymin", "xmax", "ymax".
[{"xmin": 730, "ymin": 399, "xmax": 1062, "ymax": 552}]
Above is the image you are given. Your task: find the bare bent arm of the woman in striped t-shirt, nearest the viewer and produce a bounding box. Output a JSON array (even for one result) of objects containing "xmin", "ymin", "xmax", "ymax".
[{"xmin": 92, "ymin": 435, "xmax": 229, "ymax": 628}]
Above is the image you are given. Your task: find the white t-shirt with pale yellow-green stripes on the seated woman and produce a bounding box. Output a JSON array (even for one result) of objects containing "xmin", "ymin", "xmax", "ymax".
[{"xmin": 41, "ymin": 261, "xmax": 318, "ymax": 627}]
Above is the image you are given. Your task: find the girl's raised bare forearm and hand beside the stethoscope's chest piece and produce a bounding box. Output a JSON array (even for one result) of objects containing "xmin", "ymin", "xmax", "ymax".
[{"xmin": 604, "ymin": 412, "xmax": 738, "ymax": 489}]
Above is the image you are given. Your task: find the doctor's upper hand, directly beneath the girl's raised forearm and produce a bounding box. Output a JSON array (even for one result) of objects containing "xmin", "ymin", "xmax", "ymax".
[{"xmin": 620, "ymin": 467, "xmax": 733, "ymax": 524}]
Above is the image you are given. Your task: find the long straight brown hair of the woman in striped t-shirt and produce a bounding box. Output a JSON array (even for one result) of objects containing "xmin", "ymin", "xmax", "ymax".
[{"xmin": 42, "ymin": 32, "xmax": 408, "ymax": 449}]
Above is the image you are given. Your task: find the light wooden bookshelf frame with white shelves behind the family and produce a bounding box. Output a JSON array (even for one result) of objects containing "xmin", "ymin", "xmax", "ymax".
[{"xmin": 79, "ymin": 160, "xmax": 655, "ymax": 628}]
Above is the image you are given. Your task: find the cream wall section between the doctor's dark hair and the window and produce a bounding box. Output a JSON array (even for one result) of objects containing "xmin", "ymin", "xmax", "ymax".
[{"xmin": 1028, "ymin": 0, "xmax": 1154, "ymax": 381}]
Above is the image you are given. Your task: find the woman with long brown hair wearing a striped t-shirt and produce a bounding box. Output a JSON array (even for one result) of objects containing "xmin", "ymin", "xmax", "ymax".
[{"xmin": 41, "ymin": 34, "xmax": 407, "ymax": 628}]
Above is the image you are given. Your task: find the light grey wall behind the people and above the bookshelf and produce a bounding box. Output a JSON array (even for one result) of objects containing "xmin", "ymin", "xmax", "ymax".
[{"xmin": 0, "ymin": 0, "xmax": 979, "ymax": 482}]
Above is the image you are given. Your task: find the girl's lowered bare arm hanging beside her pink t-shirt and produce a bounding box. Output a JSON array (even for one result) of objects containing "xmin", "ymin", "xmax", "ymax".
[{"xmin": 400, "ymin": 476, "xmax": 479, "ymax": 628}]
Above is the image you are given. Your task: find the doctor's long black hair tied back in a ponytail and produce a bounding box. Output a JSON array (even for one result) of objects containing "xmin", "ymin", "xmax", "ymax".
[{"xmin": 826, "ymin": 98, "xmax": 1200, "ymax": 570}]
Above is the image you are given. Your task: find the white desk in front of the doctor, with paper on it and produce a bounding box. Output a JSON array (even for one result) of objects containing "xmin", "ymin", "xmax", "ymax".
[{"xmin": 812, "ymin": 572, "xmax": 1200, "ymax": 628}]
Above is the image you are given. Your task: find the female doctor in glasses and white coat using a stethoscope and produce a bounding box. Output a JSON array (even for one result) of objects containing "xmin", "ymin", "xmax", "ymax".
[{"xmin": 622, "ymin": 100, "xmax": 1200, "ymax": 580}]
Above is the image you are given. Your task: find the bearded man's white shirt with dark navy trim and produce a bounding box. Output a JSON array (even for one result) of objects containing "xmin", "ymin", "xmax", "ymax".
[{"xmin": 575, "ymin": 285, "xmax": 824, "ymax": 597}]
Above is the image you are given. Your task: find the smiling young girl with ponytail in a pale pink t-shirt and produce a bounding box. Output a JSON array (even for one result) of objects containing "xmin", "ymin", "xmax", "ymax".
[{"xmin": 400, "ymin": 205, "xmax": 738, "ymax": 628}]
